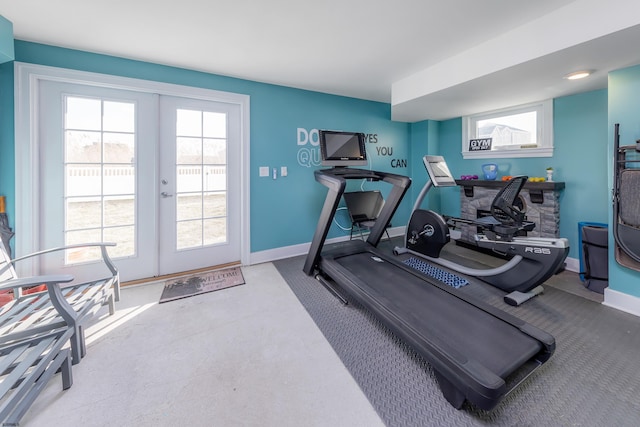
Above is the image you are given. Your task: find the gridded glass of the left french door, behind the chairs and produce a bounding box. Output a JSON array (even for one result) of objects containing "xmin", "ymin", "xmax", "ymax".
[{"xmin": 64, "ymin": 96, "xmax": 136, "ymax": 263}]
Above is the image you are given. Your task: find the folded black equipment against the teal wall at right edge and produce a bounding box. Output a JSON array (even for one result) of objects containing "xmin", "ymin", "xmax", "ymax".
[{"xmin": 613, "ymin": 123, "xmax": 640, "ymax": 271}]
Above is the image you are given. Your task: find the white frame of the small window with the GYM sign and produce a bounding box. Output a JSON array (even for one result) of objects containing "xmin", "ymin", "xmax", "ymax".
[{"xmin": 462, "ymin": 99, "xmax": 553, "ymax": 159}]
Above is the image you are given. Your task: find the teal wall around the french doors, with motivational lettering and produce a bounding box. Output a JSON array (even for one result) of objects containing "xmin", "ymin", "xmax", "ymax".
[{"xmin": 0, "ymin": 41, "xmax": 411, "ymax": 252}]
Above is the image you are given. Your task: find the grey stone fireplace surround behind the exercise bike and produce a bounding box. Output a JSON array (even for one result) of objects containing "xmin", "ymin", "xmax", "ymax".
[{"xmin": 460, "ymin": 186, "xmax": 560, "ymax": 242}]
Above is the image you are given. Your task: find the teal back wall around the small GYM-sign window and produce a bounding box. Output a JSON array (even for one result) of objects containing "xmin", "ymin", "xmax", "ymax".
[{"xmin": 423, "ymin": 90, "xmax": 611, "ymax": 258}]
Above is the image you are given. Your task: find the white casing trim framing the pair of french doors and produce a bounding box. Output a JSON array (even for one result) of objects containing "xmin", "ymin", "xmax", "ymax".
[{"xmin": 14, "ymin": 62, "xmax": 251, "ymax": 274}]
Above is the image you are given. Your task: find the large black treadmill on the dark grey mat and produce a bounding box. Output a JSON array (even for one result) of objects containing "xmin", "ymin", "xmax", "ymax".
[{"xmin": 303, "ymin": 167, "xmax": 555, "ymax": 410}]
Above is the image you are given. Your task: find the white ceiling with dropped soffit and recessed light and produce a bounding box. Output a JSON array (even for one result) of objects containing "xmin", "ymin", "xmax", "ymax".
[{"xmin": 0, "ymin": 0, "xmax": 640, "ymax": 121}]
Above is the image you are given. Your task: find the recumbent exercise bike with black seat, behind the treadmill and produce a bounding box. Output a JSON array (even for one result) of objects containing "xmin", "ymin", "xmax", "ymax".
[{"xmin": 394, "ymin": 156, "xmax": 569, "ymax": 306}]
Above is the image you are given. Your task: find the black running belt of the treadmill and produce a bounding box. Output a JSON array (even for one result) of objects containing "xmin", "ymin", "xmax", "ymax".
[{"xmin": 334, "ymin": 251, "xmax": 542, "ymax": 379}]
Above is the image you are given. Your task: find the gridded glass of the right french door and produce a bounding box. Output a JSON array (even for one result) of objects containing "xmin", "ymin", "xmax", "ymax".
[{"xmin": 175, "ymin": 109, "xmax": 227, "ymax": 249}]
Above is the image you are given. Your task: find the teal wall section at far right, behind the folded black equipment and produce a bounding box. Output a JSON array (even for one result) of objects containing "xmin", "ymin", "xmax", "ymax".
[{"xmin": 608, "ymin": 66, "xmax": 640, "ymax": 297}]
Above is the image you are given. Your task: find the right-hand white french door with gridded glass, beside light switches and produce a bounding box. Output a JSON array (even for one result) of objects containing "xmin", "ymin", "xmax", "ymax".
[{"xmin": 158, "ymin": 96, "xmax": 241, "ymax": 274}]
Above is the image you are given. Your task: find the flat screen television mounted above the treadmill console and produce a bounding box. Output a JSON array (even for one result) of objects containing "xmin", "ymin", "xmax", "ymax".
[{"xmin": 318, "ymin": 130, "xmax": 367, "ymax": 167}]
